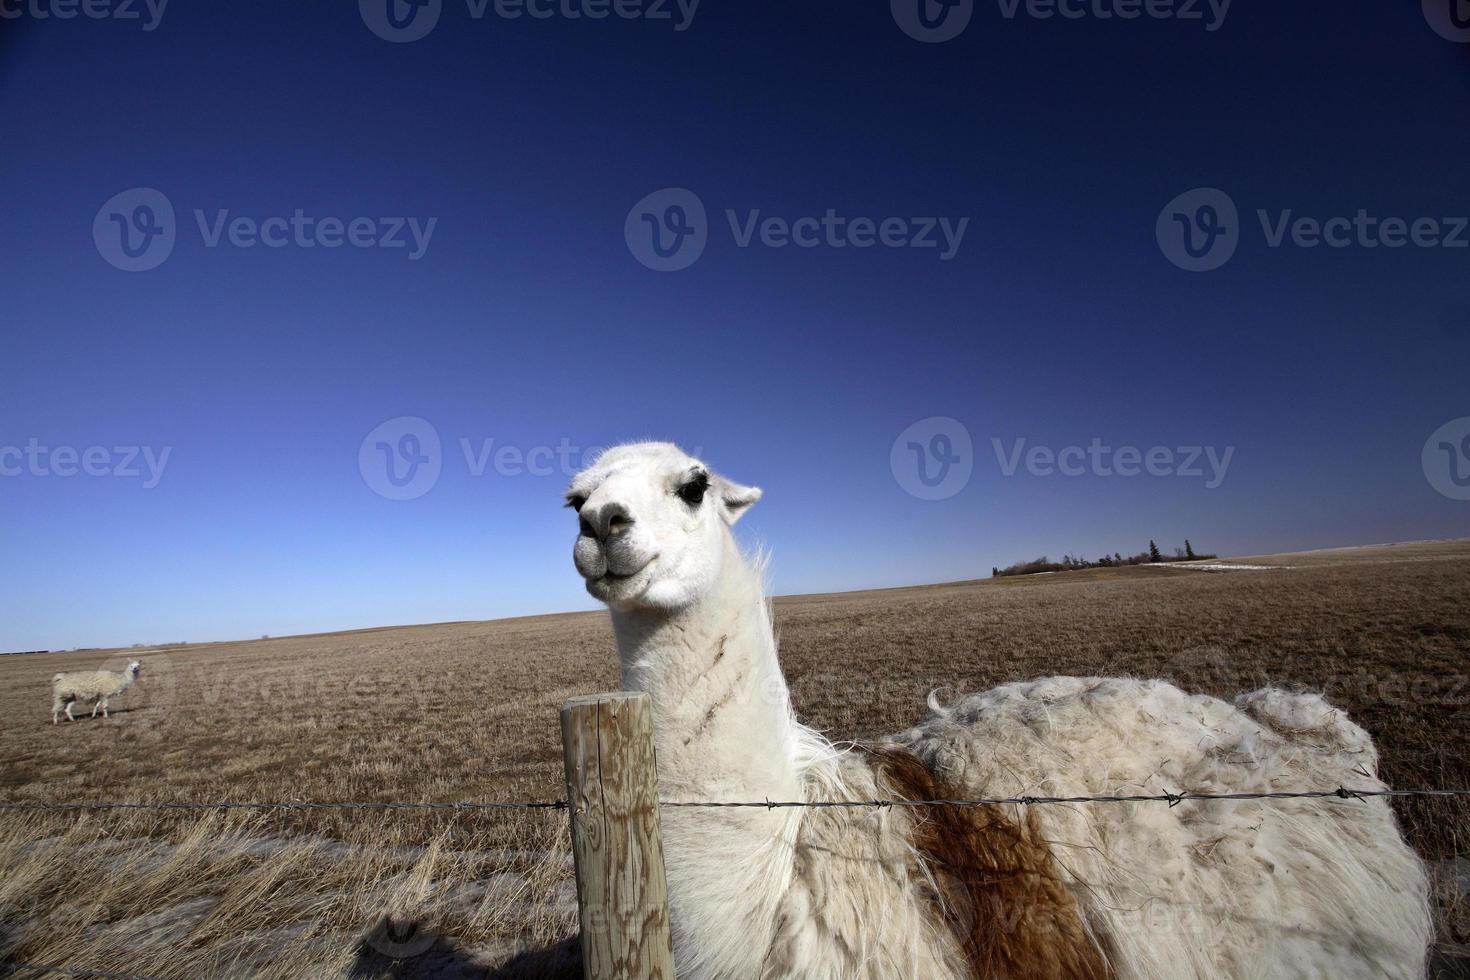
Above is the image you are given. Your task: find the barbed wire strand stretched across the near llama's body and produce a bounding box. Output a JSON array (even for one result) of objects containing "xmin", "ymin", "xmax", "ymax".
[{"xmin": 0, "ymin": 786, "xmax": 1470, "ymax": 813}]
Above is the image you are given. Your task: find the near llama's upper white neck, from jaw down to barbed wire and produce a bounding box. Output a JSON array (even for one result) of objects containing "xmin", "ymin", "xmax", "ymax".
[{"xmin": 613, "ymin": 535, "xmax": 803, "ymax": 801}]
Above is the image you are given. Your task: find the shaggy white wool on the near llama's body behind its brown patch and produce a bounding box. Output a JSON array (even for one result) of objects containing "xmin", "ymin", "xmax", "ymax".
[{"xmin": 898, "ymin": 677, "xmax": 1432, "ymax": 979}]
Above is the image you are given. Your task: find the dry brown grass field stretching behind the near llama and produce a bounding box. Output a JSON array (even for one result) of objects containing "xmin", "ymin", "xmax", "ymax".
[{"xmin": 0, "ymin": 542, "xmax": 1470, "ymax": 980}]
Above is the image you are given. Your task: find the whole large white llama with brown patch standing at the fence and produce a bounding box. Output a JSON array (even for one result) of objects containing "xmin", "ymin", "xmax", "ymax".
[{"xmin": 567, "ymin": 442, "xmax": 1432, "ymax": 980}]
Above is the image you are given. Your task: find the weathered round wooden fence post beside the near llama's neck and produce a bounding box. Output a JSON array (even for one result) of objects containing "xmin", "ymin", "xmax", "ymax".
[{"xmin": 562, "ymin": 691, "xmax": 675, "ymax": 980}]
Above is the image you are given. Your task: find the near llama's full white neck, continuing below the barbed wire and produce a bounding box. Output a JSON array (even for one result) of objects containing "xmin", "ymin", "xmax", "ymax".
[{"xmin": 613, "ymin": 538, "xmax": 819, "ymax": 980}]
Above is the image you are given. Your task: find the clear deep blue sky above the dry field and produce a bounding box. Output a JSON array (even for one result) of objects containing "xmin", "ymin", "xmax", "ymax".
[{"xmin": 0, "ymin": 0, "xmax": 1470, "ymax": 649}]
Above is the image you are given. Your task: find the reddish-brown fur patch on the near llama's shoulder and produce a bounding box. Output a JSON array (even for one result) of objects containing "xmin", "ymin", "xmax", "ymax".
[{"xmin": 864, "ymin": 745, "xmax": 1113, "ymax": 980}]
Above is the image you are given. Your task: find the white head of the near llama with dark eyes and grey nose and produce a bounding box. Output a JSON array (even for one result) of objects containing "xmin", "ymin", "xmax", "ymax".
[{"xmin": 566, "ymin": 442, "xmax": 760, "ymax": 610}]
